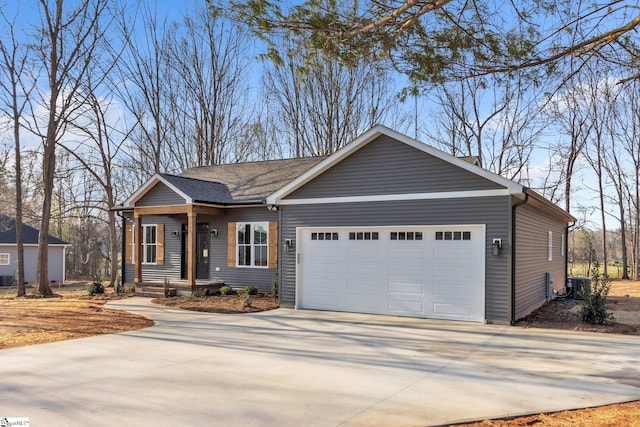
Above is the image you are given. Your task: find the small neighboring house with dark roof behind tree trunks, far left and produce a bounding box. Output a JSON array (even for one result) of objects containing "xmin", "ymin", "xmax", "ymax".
[{"xmin": 0, "ymin": 214, "xmax": 69, "ymax": 285}]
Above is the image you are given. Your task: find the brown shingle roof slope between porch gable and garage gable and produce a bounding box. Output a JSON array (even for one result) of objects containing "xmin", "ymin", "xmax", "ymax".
[{"xmin": 180, "ymin": 157, "xmax": 325, "ymax": 203}]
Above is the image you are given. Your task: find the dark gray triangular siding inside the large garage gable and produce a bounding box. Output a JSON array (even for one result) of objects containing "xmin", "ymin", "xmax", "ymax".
[{"xmin": 287, "ymin": 136, "xmax": 502, "ymax": 199}]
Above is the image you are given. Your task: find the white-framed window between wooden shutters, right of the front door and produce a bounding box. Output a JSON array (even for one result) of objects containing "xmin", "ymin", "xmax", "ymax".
[{"xmin": 236, "ymin": 222, "xmax": 269, "ymax": 268}]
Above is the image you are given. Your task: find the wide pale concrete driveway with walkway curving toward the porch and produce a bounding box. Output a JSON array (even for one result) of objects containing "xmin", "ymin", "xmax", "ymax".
[{"xmin": 0, "ymin": 298, "xmax": 640, "ymax": 426}]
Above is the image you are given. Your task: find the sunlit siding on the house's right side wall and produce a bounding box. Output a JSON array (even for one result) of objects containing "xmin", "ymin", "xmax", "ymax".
[{"xmin": 514, "ymin": 203, "xmax": 566, "ymax": 320}]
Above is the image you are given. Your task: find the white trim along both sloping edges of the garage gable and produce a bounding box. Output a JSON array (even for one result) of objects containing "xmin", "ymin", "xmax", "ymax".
[{"xmin": 266, "ymin": 125, "xmax": 523, "ymax": 205}]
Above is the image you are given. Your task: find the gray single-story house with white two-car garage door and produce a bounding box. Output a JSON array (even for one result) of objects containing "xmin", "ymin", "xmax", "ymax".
[{"xmin": 120, "ymin": 126, "xmax": 575, "ymax": 323}]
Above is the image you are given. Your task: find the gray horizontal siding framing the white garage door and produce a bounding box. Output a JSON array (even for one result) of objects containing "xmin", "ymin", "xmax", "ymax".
[{"xmin": 280, "ymin": 196, "xmax": 511, "ymax": 322}]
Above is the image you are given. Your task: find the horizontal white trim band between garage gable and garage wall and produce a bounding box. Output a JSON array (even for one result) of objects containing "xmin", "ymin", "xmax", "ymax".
[{"xmin": 278, "ymin": 188, "xmax": 510, "ymax": 205}]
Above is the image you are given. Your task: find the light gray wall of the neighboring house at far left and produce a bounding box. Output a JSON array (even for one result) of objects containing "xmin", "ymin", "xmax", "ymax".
[{"xmin": 0, "ymin": 245, "xmax": 65, "ymax": 283}]
